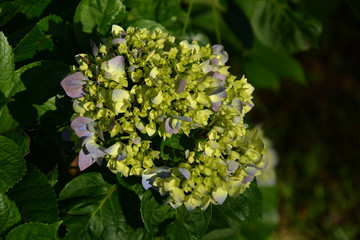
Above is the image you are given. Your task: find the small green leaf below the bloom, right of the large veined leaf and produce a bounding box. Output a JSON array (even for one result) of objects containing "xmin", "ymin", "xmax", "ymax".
[{"xmin": 140, "ymin": 190, "xmax": 175, "ymax": 236}]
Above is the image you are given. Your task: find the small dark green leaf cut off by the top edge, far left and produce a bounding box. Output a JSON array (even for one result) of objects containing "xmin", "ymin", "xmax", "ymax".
[{"xmin": 15, "ymin": 0, "xmax": 51, "ymax": 18}]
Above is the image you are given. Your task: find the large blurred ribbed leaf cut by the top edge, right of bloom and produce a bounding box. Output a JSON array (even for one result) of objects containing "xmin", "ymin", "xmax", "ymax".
[{"xmin": 237, "ymin": 0, "xmax": 322, "ymax": 53}]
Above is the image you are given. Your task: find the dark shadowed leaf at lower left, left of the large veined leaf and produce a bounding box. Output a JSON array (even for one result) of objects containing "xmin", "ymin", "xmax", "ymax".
[{"xmin": 8, "ymin": 165, "xmax": 59, "ymax": 223}]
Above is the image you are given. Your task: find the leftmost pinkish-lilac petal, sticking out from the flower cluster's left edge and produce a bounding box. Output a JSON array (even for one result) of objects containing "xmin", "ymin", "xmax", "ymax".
[{"xmin": 61, "ymin": 72, "xmax": 89, "ymax": 98}]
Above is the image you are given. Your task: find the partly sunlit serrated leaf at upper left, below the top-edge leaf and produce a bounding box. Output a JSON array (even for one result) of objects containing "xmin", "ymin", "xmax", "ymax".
[{"xmin": 14, "ymin": 15, "xmax": 62, "ymax": 62}]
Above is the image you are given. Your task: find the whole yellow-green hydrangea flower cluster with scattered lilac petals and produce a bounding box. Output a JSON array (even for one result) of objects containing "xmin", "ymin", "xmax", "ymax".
[{"xmin": 61, "ymin": 25, "xmax": 267, "ymax": 211}]
